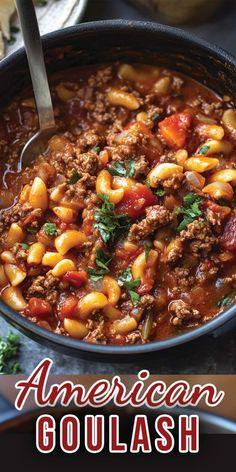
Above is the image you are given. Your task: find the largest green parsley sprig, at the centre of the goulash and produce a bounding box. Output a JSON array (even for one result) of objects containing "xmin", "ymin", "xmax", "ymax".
[{"xmin": 94, "ymin": 194, "xmax": 131, "ymax": 243}]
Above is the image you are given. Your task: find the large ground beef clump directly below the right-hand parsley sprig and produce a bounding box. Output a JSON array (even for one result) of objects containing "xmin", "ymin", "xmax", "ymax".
[{"xmin": 180, "ymin": 218, "xmax": 217, "ymax": 255}]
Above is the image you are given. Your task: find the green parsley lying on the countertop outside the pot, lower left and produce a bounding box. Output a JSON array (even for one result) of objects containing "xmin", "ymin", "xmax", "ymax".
[{"xmin": 0, "ymin": 331, "xmax": 20, "ymax": 374}]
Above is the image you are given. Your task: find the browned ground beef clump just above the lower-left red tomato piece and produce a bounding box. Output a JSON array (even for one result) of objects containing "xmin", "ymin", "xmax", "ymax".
[{"xmin": 26, "ymin": 273, "xmax": 60, "ymax": 305}]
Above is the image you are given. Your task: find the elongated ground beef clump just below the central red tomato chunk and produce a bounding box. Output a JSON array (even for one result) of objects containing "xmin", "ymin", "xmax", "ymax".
[{"xmin": 128, "ymin": 205, "xmax": 172, "ymax": 241}]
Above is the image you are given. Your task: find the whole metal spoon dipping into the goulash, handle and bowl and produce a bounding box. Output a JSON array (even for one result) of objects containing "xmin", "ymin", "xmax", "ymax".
[{"xmin": 16, "ymin": 0, "xmax": 56, "ymax": 171}]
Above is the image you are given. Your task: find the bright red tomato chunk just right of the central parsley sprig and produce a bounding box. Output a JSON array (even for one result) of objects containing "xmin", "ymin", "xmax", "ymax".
[{"xmin": 116, "ymin": 183, "xmax": 157, "ymax": 218}]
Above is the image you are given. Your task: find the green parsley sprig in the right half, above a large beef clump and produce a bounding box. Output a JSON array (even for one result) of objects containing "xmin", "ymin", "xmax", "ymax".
[{"xmin": 175, "ymin": 192, "xmax": 202, "ymax": 232}]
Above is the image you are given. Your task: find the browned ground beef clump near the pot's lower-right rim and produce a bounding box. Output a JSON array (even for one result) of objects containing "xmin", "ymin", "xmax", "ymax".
[{"xmin": 168, "ymin": 300, "xmax": 201, "ymax": 328}]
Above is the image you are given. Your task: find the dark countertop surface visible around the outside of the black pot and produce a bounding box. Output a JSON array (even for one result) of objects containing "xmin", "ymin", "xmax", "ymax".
[{"xmin": 0, "ymin": 0, "xmax": 236, "ymax": 374}]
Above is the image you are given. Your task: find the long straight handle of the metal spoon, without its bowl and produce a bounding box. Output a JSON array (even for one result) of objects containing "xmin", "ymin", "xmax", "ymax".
[{"xmin": 16, "ymin": 0, "xmax": 55, "ymax": 130}]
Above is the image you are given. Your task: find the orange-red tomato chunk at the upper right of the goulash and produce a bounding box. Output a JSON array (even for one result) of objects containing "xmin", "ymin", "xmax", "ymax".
[{"xmin": 159, "ymin": 113, "xmax": 192, "ymax": 149}]
